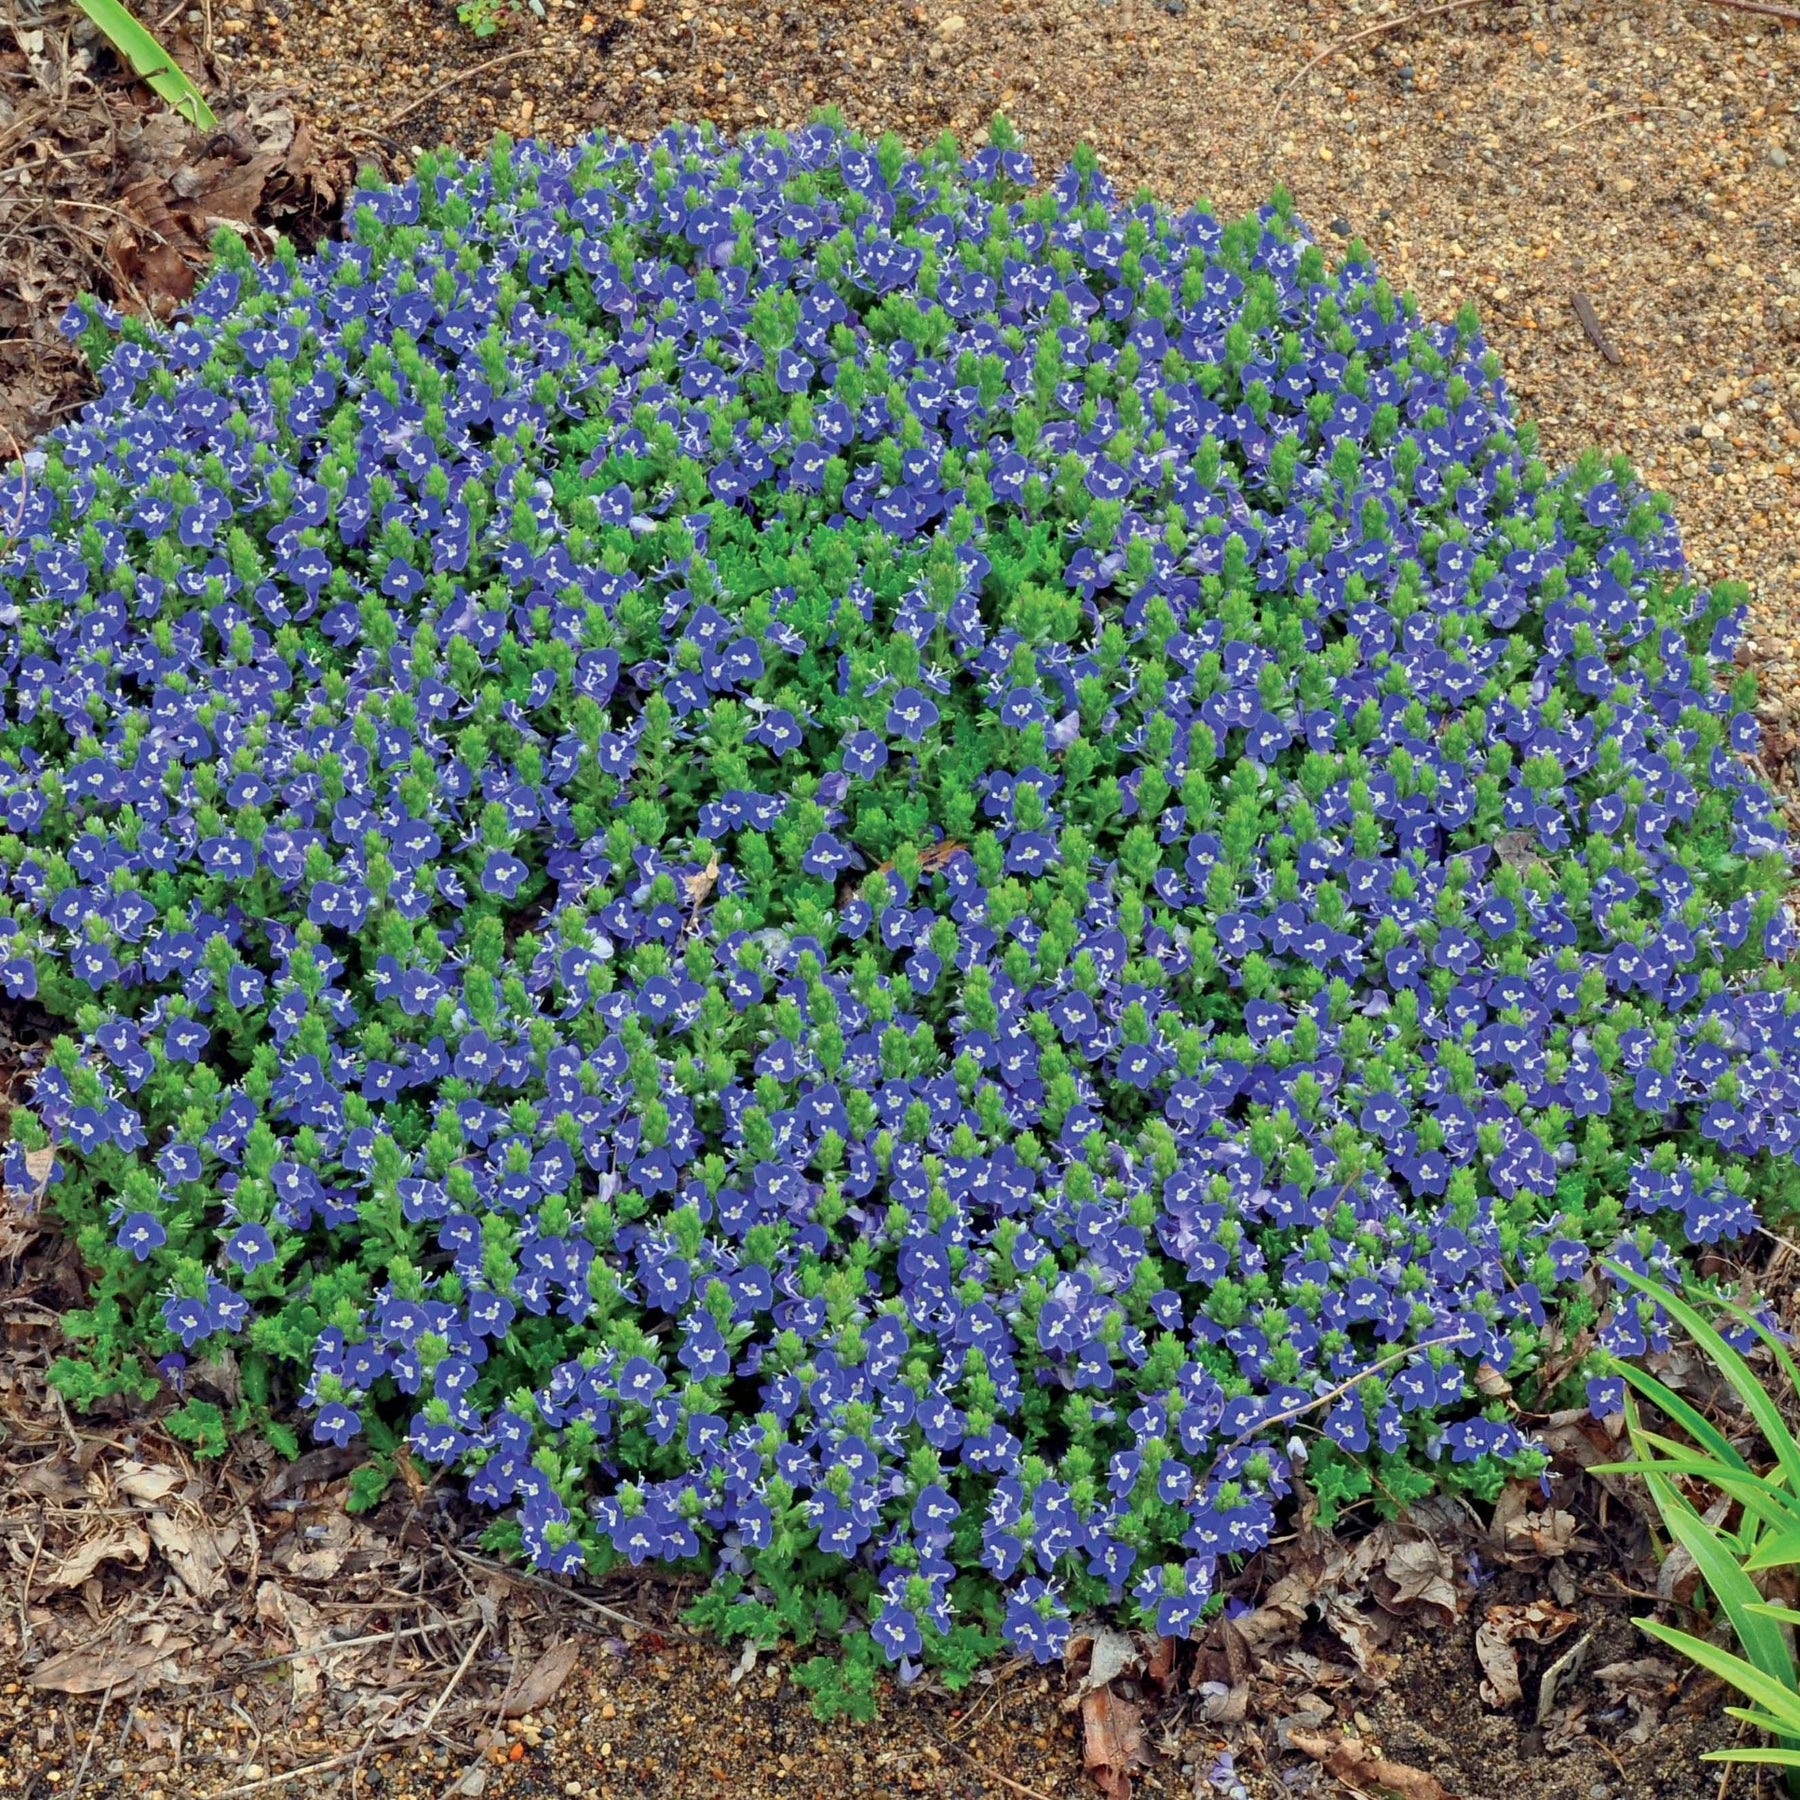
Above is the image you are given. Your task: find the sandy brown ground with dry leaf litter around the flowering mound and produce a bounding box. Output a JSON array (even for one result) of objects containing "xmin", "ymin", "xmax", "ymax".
[{"xmin": 0, "ymin": 0, "xmax": 1800, "ymax": 1800}]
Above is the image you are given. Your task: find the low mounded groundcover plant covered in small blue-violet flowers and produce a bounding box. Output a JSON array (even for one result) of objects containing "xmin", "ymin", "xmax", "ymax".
[{"xmin": 0, "ymin": 121, "xmax": 1800, "ymax": 1679}]
